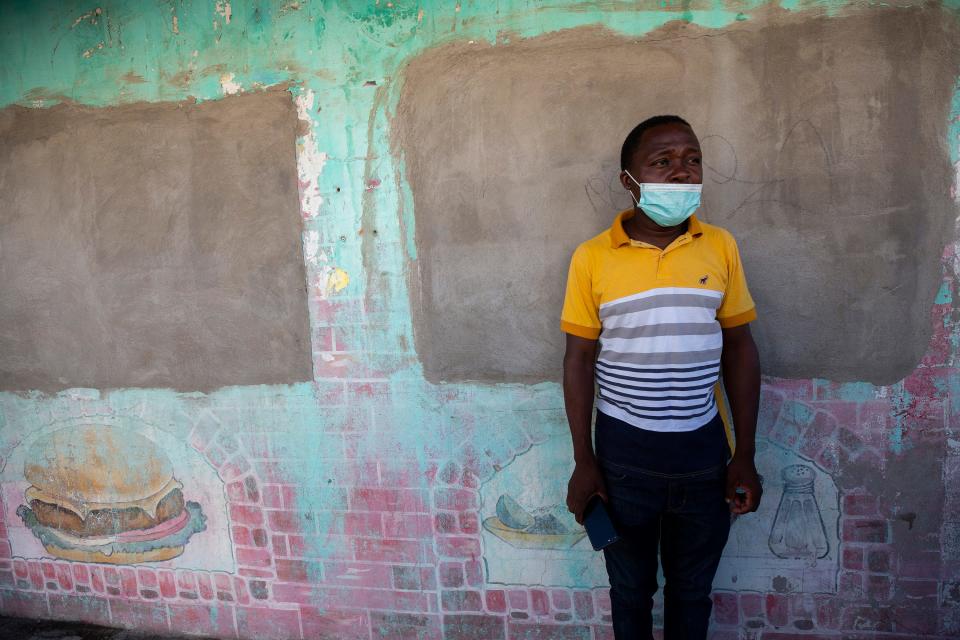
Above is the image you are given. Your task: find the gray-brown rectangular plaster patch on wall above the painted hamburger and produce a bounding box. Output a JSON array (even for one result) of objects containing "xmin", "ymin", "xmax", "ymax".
[{"xmin": 0, "ymin": 91, "xmax": 311, "ymax": 390}]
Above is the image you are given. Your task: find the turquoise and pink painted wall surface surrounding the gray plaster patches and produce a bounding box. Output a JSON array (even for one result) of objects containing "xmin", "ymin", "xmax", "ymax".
[{"xmin": 0, "ymin": 0, "xmax": 960, "ymax": 638}]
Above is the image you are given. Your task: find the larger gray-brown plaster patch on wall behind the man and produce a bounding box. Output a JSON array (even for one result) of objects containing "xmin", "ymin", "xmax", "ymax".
[{"xmin": 395, "ymin": 5, "xmax": 960, "ymax": 383}]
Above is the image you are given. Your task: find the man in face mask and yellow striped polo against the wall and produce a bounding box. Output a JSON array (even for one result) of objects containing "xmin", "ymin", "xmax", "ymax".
[{"xmin": 561, "ymin": 116, "xmax": 761, "ymax": 640}]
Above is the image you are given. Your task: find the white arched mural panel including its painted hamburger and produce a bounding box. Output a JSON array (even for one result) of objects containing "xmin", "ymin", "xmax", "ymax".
[{"xmin": 0, "ymin": 420, "xmax": 234, "ymax": 570}]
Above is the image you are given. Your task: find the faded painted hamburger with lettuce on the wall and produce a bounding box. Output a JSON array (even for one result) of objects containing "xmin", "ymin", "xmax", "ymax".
[{"xmin": 17, "ymin": 425, "xmax": 206, "ymax": 564}]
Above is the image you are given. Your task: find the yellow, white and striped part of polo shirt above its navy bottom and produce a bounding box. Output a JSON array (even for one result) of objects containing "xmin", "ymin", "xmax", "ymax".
[{"xmin": 561, "ymin": 209, "xmax": 756, "ymax": 432}]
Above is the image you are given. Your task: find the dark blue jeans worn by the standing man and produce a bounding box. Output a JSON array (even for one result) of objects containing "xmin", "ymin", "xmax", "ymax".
[{"xmin": 600, "ymin": 459, "xmax": 730, "ymax": 640}]
